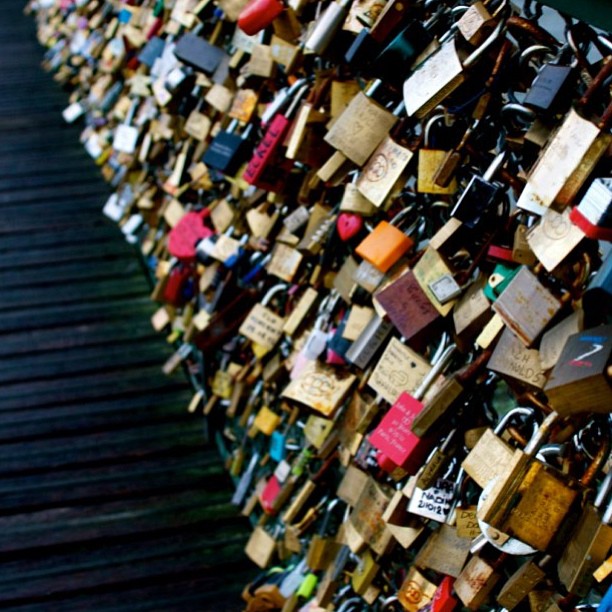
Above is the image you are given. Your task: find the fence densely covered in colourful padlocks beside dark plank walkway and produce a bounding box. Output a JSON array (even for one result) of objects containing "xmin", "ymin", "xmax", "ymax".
[{"xmin": 28, "ymin": 0, "xmax": 612, "ymax": 612}]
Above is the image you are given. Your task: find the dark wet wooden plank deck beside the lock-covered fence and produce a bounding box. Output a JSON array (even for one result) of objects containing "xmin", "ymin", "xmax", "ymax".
[{"xmin": 0, "ymin": 0, "xmax": 254, "ymax": 612}]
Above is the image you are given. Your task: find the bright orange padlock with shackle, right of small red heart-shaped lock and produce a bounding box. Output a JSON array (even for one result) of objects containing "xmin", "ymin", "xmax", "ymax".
[{"xmin": 355, "ymin": 208, "xmax": 418, "ymax": 272}]
